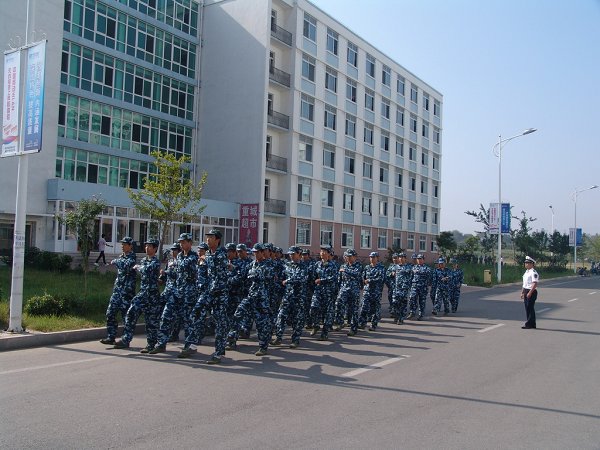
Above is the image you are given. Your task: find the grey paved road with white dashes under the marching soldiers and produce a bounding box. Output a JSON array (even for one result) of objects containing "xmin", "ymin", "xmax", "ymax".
[{"xmin": 0, "ymin": 277, "xmax": 600, "ymax": 449}]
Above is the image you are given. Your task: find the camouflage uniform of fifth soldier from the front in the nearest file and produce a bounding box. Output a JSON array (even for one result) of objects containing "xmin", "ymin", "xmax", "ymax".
[{"xmin": 335, "ymin": 261, "xmax": 363, "ymax": 334}]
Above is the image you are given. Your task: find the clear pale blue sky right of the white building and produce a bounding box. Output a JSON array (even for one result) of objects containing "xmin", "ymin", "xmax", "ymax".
[{"xmin": 311, "ymin": 0, "xmax": 600, "ymax": 234}]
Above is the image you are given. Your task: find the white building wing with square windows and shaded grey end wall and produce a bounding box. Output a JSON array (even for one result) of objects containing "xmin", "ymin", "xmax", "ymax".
[{"xmin": 199, "ymin": 0, "xmax": 442, "ymax": 256}]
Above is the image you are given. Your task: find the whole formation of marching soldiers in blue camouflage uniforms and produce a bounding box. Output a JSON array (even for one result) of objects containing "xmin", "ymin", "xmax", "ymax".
[{"xmin": 100, "ymin": 229, "xmax": 463, "ymax": 364}]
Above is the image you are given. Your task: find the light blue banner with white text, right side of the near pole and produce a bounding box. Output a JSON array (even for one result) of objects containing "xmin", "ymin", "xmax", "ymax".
[{"xmin": 23, "ymin": 41, "xmax": 46, "ymax": 153}]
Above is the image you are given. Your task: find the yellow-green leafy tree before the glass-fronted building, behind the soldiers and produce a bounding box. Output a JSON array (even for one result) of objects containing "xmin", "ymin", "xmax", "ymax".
[{"xmin": 127, "ymin": 151, "xmax": 207, "ymax": 254}]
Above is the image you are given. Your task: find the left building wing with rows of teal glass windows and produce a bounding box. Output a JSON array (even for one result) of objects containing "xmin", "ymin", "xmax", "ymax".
[{"xmin": 0, "ymin": 0, "xmax": 239, "ymax": 252}]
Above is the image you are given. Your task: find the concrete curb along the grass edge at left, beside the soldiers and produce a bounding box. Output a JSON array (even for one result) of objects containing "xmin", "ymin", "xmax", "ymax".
[{"xmin": 0, "ymin": 323, "xmax": 146, "ymax": 352}]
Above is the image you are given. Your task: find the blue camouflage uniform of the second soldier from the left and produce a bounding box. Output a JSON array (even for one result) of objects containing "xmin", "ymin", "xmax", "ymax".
[{"xmin": 121, "ymin": 255, "xmax": 162, "ymax": 349}]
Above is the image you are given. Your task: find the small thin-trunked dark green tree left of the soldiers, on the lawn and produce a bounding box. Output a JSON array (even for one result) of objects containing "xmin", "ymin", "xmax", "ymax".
[{"xmin": 57, "ymin": 197, "xmax": 106, "ymax": 298}]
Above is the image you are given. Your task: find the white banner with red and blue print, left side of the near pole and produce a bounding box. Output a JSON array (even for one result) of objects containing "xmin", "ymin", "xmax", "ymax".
[{"xmin": 2, "ymin": 51, "xmax": 21, "ymax": 157}]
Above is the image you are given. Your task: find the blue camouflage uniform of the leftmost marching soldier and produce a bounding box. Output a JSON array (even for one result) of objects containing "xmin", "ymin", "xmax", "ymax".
[{"xmin": 106, "ymin": 251, "xmax": 136, "ymax": 341}]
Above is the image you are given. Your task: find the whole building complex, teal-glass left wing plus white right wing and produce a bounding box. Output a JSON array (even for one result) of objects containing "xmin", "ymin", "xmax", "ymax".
[{"xmin": 0, "ymin": 0, "xmax": 442, "ymax": 256}]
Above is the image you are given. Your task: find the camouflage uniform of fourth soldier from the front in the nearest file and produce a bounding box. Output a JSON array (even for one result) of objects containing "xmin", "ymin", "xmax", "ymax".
[{"xmin": 310, "ymin": 260, "xmax": 338, "ymax": 339}]
